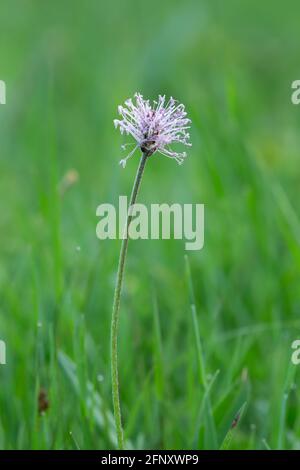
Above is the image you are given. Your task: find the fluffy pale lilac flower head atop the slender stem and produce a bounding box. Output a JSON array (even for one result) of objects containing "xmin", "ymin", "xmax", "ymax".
[{"xmin": 114, "ymin": 93, "xmax": 192, "ymax": 168}]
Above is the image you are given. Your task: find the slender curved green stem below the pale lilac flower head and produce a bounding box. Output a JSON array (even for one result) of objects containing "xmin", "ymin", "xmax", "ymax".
[{"xmin": 111, "ymin": 153, "xmax": 148, "ymax": 450}]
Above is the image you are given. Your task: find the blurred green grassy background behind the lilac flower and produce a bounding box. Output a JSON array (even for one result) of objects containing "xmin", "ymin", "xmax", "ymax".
[{"xmin": 0, "ymin": 0, "xmax": 300, "ymax": 449}]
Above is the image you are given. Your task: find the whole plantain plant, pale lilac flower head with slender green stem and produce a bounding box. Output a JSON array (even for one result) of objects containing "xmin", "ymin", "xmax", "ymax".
[{"xmin": 111, "ymin": 93, "xmax": 191, "ymax": 449}]
